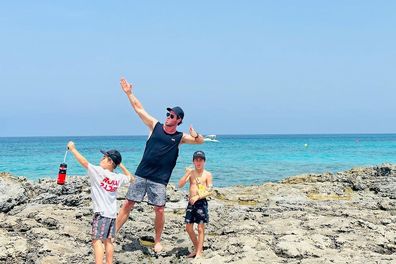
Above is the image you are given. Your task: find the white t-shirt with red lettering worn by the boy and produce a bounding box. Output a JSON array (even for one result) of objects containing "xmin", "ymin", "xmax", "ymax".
[{"xmin": 87, "ymin": 163, "xmax": 129, "ymax": 218}]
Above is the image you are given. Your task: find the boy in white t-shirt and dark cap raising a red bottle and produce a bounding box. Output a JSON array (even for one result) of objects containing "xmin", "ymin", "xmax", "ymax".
[{"xmin": 67, "ymin": 141, "xmax": 134, "ymax": 264}]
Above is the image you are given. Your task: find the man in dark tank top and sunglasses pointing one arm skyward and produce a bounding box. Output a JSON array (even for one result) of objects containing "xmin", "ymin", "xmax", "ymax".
[{"xmin": 116, "ymin": 79, "xmax": 204, "ymax": 252}]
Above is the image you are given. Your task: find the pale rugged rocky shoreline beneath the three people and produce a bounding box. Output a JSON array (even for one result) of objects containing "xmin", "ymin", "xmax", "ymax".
[{"xmin": 0, "ymin": 164, "xmax": 396, "ymax": 264}]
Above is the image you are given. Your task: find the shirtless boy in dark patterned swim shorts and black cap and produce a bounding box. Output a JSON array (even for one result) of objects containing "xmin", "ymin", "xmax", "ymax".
[{"xmin": 179, "ymin": 151, "xmax": 213, "ymax": 258}]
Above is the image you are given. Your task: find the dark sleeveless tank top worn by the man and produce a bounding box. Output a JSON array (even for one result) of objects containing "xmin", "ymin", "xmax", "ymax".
[{"xmin": 135, "ymin": 122, "xmax": 183, "ymax": 185}]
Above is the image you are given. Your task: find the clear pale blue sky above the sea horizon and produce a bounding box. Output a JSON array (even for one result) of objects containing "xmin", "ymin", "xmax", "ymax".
[{"xmin": 0, "ymin": 0, "xmax": 396, "ymax": 136}]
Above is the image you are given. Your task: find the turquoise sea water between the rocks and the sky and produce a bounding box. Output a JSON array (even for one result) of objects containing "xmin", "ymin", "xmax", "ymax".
[{"xmin": 0, "ymin": 134, "xmax": 396, "ymax": 186}]
